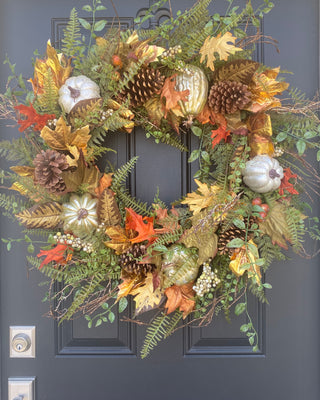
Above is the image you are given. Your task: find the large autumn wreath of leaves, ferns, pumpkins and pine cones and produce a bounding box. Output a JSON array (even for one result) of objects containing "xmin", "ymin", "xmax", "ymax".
[{"xmin": 0, "ymin": 0, "xmax": 320, "ymax": 357}]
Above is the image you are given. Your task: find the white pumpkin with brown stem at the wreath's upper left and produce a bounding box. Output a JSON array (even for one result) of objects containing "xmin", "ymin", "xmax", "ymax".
[{"xmin": 59, "ymin": 75, "xmax": 100, "ymax": 113}]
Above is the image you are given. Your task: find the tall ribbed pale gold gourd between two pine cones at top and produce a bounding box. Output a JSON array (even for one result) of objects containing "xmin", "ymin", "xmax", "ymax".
[{"xmin": 175, "ymin": 65, "xmax": 208, "ymax": 120}]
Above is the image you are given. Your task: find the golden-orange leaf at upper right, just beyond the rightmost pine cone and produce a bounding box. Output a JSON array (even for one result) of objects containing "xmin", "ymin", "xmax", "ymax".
[{"xmin": 248, "ymin": 67, "xmax": 289, "ymax": 113}]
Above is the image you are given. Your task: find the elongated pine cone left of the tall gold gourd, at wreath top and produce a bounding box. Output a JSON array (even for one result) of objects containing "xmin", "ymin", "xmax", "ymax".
[{"xmin": 121, "ymin": 67, "xmax": 165, "ymax": 107}]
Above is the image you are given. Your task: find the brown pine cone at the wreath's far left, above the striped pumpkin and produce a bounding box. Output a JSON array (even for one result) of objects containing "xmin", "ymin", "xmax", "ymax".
[{"xmin": 33, "ymin": 150, "xmax": 69, "ymax": 193}]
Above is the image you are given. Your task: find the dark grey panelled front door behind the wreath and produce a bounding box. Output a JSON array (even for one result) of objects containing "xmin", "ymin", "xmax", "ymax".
[{"xmin": 0, "ymin": 0, "xmax": 320, "ymax": 400}]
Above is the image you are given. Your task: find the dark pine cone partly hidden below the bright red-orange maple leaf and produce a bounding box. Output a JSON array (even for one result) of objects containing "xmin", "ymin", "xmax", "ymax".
[{"xmin": 120, "ymin": 243, "xmax": 156, "ymax": 276}]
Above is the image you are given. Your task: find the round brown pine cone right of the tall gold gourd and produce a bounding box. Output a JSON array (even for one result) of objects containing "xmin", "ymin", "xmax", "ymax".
[{"xmin": 208, "ymin": 81, "xmax": 251, "ymax": 114}]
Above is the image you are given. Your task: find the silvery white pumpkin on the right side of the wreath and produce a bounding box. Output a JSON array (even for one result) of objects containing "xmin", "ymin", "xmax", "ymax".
[{"xmin": 242, "ymin": 155, "xmax": 283, "ymax": 193}]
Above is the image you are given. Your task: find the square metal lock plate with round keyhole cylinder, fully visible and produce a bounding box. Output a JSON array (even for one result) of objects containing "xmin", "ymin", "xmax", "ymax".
[{"xmin": 10, "ymin": 326, "xmax": 36, "ymax": 358}]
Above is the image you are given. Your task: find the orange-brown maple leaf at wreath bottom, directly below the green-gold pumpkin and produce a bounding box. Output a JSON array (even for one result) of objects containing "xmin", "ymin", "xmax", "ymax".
[{"xmin": 165, "ymin": 282, "xmax": 196, "ymax": 319}]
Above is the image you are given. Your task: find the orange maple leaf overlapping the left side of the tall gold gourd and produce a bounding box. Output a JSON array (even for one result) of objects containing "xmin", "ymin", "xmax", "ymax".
[{"xmin": 161, "ymin": 74, "xmax": 190, "ymax": 118}]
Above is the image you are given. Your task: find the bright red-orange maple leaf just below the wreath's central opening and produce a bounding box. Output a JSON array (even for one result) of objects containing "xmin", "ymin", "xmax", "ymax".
[{"xmin": 126, "ymin": 208, "xmax": 156, "ymax": 243}]
